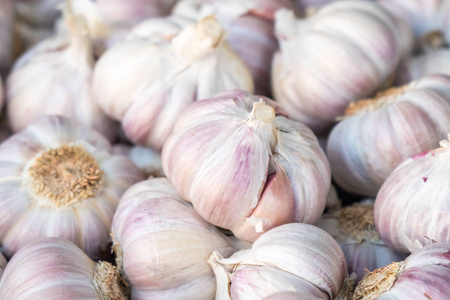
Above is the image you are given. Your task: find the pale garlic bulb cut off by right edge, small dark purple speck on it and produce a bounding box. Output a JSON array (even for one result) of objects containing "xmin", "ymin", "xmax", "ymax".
[{"xmin": 374, "ymin": 136, "xmax": 450, "ymax": 252}]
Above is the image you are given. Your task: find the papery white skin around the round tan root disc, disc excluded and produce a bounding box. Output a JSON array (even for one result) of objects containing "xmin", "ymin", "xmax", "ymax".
[{"xmin": 0, "ymin": 116, "xmax": 142, "ymax": 258}]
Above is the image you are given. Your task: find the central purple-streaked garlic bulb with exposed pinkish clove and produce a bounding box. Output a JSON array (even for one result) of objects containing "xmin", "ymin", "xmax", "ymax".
[{"xmin": 162, "ymin": 91, "xmax": 330, "ymax": 241}]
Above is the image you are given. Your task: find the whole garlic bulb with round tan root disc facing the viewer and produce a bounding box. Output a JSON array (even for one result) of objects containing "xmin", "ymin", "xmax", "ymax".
[{"xmin": 0, "ymin": 116, "xmax": 142, "ymax": 257}]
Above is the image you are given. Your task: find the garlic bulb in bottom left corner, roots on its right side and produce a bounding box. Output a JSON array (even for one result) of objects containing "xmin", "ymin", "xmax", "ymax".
[{"xmin": 0, "ymin": 238, "xmax": 127, "ymax": 300}]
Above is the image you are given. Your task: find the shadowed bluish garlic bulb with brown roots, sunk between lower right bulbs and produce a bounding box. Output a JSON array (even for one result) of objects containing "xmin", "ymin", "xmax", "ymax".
[{"xmin": 316, "ymin": 201, "xmax": 407, "ymax": 283}]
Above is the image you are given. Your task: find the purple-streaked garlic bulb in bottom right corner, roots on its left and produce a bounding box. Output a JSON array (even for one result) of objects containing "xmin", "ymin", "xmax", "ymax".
[{"xmin": 351, "ymin": 243, "xmax": 450, "ymax": 300}]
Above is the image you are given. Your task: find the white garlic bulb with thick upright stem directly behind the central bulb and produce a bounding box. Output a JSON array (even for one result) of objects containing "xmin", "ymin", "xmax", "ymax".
[{"xmin": 94, "ymin": 17, "xmax": 253, "ymax": 150}]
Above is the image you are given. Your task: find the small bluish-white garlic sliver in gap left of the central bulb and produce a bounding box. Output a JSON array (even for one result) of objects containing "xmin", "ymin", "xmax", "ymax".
[{"xmin": 112, "ymin": 144, "xmax": 165, "ymax": 178}]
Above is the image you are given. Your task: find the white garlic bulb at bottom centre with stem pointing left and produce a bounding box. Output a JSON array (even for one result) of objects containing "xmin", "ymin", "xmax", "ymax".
[{"xmin": 208, "ymin": 223, "xmax": 347, "ymax": 300}]
